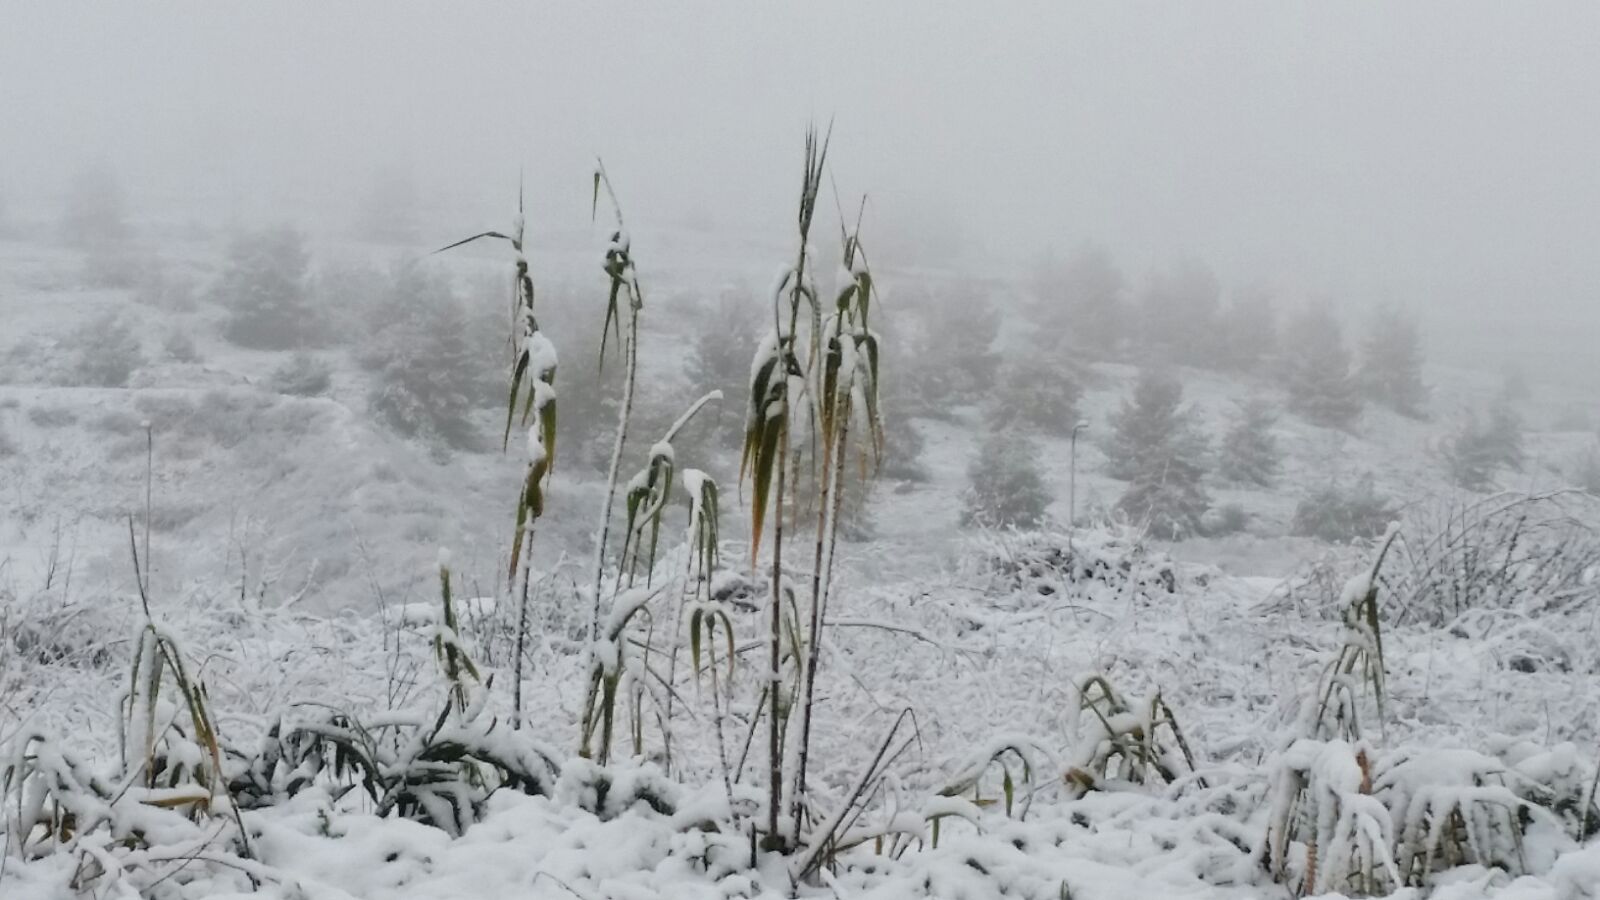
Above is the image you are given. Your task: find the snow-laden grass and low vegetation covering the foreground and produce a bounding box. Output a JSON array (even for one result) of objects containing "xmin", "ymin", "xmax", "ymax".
[{"xmin": 0, "ymin": 522, "xmax": 1600, "ymax": 900}]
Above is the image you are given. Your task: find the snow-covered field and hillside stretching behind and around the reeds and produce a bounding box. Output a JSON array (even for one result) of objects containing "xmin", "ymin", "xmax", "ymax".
[{"xmin": 0, "ymin": 227, "xmax": 1600, "ymax": 900}]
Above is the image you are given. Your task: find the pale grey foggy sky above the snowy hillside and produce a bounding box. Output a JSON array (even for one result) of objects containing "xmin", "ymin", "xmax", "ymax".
[{"xmin": 0, "ymin": 3, "xmax": 1600, "ymax": 376}]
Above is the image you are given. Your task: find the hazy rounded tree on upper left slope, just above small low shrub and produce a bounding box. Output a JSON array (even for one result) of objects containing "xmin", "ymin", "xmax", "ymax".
[{"xmin": 211, "ymin": 227, "xmax": 320, "ymax": 351}]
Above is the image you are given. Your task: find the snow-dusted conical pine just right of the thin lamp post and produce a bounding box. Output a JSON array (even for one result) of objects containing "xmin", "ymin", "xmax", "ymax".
[{"xmin": 1107, "ymin": 370, "xmax": 1211, "ymax": 540}]
